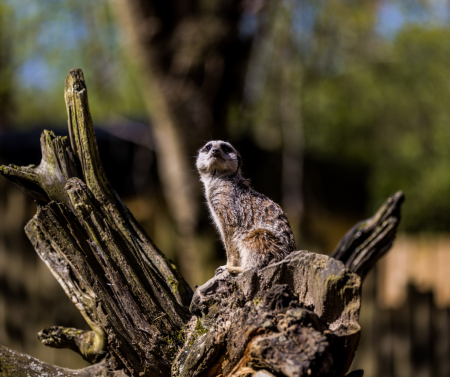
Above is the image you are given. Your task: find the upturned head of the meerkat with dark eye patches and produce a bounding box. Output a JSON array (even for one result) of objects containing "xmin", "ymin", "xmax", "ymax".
[{"xmin": 196, "ymin": 140, "xmax": 241, "ymax": 177}]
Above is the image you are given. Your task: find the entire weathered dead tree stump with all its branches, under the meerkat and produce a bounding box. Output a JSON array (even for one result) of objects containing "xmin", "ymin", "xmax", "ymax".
[{"xmin": 0, "ymin": 70, "xmax": 403, "ymax": 377}]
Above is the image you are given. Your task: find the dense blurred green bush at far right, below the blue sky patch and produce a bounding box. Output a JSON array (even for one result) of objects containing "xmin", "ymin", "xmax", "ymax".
[{"xmin": 304, "ymin": 26, "xmax": 450, "ymax": 230}]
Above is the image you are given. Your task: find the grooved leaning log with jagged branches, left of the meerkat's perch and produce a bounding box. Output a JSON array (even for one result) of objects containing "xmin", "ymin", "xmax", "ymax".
[{"xmin": 1, "ymin": 70, "xmax": 192, "ymax": 376}]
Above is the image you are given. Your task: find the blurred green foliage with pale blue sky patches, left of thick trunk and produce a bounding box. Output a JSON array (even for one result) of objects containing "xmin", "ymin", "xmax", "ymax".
[{"xmin": 0, "ymin": 0, "xmax": 144, "ymax": 127}]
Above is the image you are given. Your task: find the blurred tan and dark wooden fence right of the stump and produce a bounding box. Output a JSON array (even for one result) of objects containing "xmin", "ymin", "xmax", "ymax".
[{"xmin": 352, "ymin": 235, "xmax": 450, "ymax": 377}]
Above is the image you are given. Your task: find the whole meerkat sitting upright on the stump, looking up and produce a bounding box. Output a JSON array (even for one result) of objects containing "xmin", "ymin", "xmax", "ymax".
[{"xmin": 196, "ymin": 140, "xmax": 296, "ymax": 275}]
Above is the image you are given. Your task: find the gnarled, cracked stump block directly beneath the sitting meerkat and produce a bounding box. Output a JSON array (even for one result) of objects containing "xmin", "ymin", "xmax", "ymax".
[{"xmin": 178, "ymin": 251, "xmax": 361, "ymax": 377}]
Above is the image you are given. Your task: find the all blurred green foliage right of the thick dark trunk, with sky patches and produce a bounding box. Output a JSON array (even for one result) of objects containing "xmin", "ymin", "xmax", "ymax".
[{"xmin": 244, "ymin": 0, "xmax": 450, "ymax": 231}]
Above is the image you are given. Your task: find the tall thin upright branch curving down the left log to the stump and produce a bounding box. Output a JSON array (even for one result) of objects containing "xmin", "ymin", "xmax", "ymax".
[{"xmin": 65, "ymin": 69, "xmax": 192, "ymax": 306}]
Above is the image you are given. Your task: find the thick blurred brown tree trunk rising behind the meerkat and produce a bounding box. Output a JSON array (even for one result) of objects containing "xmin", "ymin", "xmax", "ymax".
[{"xmin": 113, "ymin": 0, "xmax": 252, "ymax": 283}]
